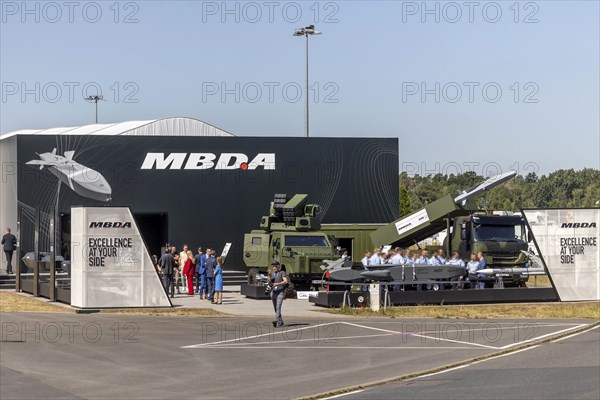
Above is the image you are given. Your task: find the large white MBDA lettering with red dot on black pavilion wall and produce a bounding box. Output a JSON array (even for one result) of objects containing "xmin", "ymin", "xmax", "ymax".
[{"xmin": 141, "ymin": 153, "xmax": 275, "ymax": 171}]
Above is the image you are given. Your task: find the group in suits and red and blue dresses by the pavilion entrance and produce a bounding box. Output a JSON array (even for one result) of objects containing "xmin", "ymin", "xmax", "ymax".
[{"xmin": 156, "ymin": 244, "xmax": 223, "ymax": 304}]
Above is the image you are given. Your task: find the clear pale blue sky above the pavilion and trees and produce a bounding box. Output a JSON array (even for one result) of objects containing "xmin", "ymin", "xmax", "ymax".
[{"xmin": 0, "ymin": 1, "xmax": 600, "ymax": 175}]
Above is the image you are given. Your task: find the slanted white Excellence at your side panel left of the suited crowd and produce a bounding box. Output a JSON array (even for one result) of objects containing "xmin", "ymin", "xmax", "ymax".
[{"xmin": 71, "ymin": 207, "xmax": 171, "ymax": 308}]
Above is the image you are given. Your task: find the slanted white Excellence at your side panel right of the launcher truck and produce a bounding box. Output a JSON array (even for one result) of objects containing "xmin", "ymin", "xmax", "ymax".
[{"xmin": 523, "ymin": 208, "xmax": 600, "ymax": 301}]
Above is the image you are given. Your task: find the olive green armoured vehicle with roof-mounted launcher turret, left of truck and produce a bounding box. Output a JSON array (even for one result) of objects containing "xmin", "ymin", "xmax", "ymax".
[{"xmin": 243, "ymin": 194, "xmax": 337, "ymax": 288}]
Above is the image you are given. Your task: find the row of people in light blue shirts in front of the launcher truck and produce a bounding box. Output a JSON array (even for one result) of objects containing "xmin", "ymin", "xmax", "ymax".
[{"xmin": 358, "ymin": 247, "xmax": 487, "ymax": 290}]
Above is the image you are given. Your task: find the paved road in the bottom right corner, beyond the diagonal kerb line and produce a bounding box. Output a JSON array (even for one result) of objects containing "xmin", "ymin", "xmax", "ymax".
[{"xmin": 340, "ymin": 327, "xmax": 600, "ymax": 400}]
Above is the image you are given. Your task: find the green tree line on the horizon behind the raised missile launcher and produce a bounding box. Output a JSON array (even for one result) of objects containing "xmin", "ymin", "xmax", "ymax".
[{"xmin": 400, "ymin": 168, "xmax": 600, "ymax": 216}]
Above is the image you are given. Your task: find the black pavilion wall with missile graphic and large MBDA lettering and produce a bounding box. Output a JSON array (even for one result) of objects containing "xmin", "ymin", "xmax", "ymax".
[{"xmin": 18, "ymin": 135, "xmax": 399, "ymax": 270}]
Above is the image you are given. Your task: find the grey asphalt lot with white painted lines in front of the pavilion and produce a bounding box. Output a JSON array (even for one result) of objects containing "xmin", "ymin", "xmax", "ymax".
[{"xmin": 0, "ymin": 313, "xmax": 599, "ymax": 400}]
